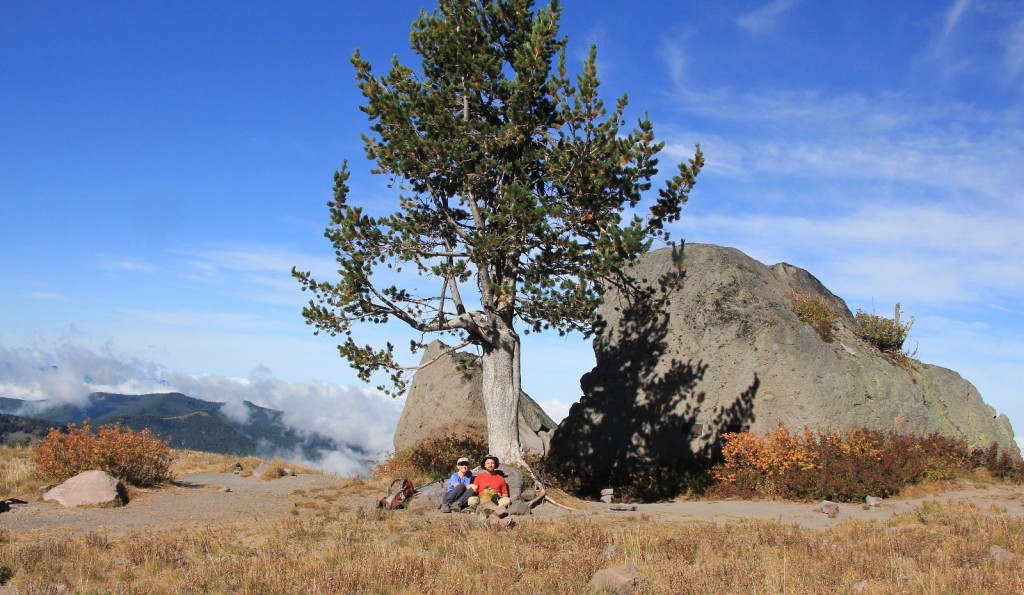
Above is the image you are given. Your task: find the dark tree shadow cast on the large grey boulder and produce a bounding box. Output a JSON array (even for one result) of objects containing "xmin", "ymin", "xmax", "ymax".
[{"xmin": 548, "ymin": 252, "xmax": 760, "ymax": 500}]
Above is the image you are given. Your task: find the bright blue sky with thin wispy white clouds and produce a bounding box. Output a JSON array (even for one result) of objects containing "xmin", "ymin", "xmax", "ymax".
[{"xmin": 0, "ymin": 0, "xmax": 1024, "ymax": 467}]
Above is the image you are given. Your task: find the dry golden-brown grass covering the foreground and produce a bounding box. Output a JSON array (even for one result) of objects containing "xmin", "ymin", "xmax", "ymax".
[{"xmin": 0, "ymin": 442, "xmax": 1024, "ymax": 593}]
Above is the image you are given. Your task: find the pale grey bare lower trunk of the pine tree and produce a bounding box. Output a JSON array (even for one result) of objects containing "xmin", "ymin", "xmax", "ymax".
[{"xmin": 482, "ymin": 333, "xmax": 524, "ymax": 465}]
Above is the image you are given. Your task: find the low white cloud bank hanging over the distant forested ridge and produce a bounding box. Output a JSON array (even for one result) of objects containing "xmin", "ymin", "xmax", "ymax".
[{"xmin": 0, "ymin": 344, "xmax": 402, "ymax": 475}]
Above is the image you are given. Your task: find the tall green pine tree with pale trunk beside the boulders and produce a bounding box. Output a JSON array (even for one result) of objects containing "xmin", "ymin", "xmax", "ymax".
[{"xmin": 292, "ymin": 0, "xmax": 703, "ymax": 463}]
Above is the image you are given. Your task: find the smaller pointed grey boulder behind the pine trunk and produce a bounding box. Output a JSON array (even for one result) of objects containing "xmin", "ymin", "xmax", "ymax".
[{"xmin": 394, "ymin": 341, "xmax": 557, "ymax": 452}]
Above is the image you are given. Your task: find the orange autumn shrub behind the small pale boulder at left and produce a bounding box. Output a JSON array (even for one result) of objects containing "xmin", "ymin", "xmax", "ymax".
[{"xmin": 35, "ymin": 421, "xmax": 174, "ymax": 487}]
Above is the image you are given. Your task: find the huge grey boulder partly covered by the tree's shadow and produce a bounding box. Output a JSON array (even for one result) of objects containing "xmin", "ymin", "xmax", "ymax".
[{"xmin": 551, "ymin": 244, "xmax": 1019, "ymax": 475}]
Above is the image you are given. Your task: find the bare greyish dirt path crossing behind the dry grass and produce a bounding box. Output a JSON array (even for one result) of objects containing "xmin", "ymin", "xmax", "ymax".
[{"xmin": 8, "ymin": 473, "xmax": 1024, "ymax": 538}]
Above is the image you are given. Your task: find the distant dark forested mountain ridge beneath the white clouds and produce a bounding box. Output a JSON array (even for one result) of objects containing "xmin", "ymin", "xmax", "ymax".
[{"xmin": 0, "ymin": 392, "xmax": 370, "ymax": 461}]
